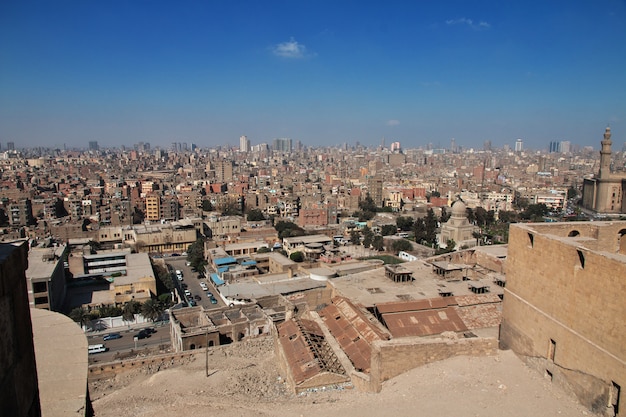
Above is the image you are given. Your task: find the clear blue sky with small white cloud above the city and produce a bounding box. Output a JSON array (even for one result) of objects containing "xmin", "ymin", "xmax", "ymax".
[{"xmin": 0, "ymin": 0, "xmax": 626, "ymax": 149}]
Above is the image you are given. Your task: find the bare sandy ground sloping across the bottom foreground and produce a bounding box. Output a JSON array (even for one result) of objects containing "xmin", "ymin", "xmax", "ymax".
[{"xmin": 90, "ymin": 339, "xmax": 594, "ymax": 417}]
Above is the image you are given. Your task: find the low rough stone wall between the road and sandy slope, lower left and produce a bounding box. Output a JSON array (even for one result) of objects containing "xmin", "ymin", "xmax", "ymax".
[{"xmin": 88, "ymin": 351, "xmax": 196, "ymax": 381}]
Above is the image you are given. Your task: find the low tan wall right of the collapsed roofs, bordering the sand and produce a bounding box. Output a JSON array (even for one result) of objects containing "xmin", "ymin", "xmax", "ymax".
[{"xmin": 370, "ymin": 333, "xmax": 498, "ymax": 392}]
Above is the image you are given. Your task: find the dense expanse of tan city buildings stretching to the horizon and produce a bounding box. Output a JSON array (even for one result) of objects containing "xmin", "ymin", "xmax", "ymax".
[{"xmin": 0, "ymin": 127, "xmax": 626, "ymax": 416}]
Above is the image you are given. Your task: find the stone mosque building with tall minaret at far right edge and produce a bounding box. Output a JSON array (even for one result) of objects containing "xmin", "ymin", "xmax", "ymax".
[{"xmin": 582, "ymin": 127, "xmax": 626, "ymax": 214}]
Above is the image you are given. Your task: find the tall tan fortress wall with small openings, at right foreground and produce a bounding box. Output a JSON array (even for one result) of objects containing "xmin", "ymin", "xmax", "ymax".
[{"xmin": 500, "ymin": 222, "xmax": 626, "ymax": 416}]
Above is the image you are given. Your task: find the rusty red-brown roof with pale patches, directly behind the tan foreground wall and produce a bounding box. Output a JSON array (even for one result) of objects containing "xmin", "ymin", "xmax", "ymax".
[{"xmin": 383, "ymin": 306, "xmax": 467, "ymax": 337}]
